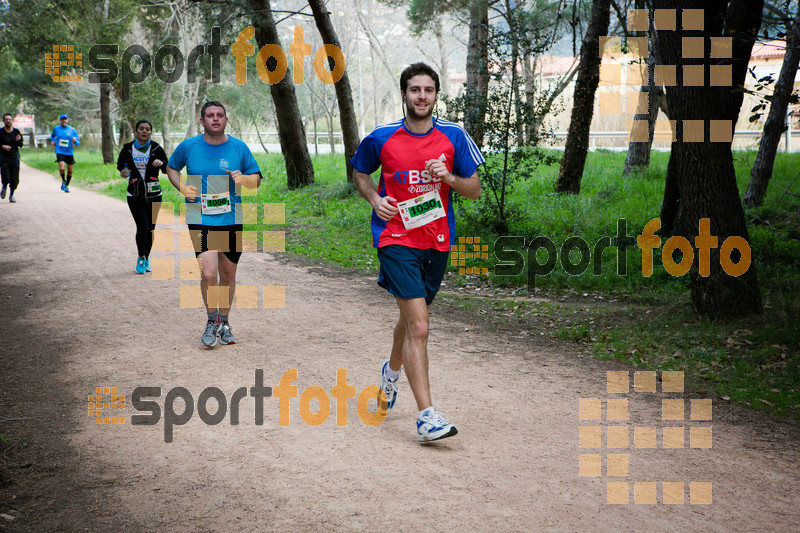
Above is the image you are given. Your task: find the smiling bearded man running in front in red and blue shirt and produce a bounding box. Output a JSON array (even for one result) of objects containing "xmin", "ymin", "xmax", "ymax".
[{"xmin": 352, "ymin": 63, "xmax": 484, "ymax": 442}]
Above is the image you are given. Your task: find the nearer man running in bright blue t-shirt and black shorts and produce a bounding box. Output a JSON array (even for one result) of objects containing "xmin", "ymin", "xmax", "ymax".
[{"xmin": 167, "ymin": 101, "xmax": 261, "ymax": 348}]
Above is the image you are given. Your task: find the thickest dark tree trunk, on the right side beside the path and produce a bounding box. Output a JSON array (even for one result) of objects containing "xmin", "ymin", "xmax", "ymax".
[{"xmin": 654, "ymin": 0, "xmax": 763, "ymax": 318}]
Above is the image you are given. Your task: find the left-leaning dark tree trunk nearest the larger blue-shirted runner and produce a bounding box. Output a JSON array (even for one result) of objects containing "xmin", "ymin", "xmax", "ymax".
[{"xmin": 249, "ymin": 0, "xmax": 314, "ymax": 189}]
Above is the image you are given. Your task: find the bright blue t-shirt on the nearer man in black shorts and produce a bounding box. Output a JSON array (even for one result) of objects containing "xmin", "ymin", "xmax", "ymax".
[{"xmin": 167, "ymin": 135, "xmax": 261, "ymax": 226}]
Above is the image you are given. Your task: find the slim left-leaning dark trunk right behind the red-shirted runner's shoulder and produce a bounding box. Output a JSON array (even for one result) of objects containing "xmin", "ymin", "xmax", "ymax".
[{"xmin": 308, "ymin": 0, "xmax": 361, "ymax": 183}]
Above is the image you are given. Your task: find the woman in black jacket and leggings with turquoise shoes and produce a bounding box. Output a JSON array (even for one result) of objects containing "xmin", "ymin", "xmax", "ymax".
[{"xmin": 117, "ymin": 120, "xmax": 168, "ymax": 274}]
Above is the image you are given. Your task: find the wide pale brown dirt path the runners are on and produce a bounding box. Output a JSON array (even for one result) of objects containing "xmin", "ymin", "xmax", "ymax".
[{"xmin": 0, "ymin": 167, "xmax": 800, "ymax": 531}]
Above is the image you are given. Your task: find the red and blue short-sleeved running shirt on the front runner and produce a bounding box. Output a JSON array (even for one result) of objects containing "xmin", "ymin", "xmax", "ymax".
[{"xmin": 350, "ymin": 117, "xmax": 485, "ymax": 252}]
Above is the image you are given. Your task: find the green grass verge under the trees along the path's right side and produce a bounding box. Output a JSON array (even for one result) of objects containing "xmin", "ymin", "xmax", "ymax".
[{"xmin": 22, "ymin": 150, "xmax": 800, "ymax": 419}]
